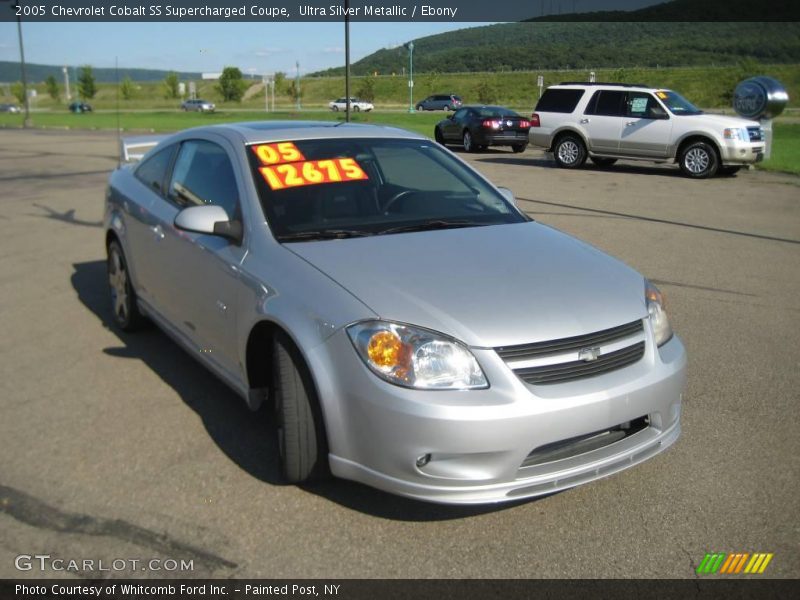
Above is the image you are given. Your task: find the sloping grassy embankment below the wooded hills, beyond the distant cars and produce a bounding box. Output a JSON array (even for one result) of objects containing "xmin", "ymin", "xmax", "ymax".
[{"xmin": 0, "ymin": 63, "xmax": 800, "ymax": 111}]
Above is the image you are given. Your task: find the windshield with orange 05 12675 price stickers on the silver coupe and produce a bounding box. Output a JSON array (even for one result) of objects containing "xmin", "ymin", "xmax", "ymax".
[{"xmin": 248, "ymin": 139, "xmax": 528, "ymax": 241}]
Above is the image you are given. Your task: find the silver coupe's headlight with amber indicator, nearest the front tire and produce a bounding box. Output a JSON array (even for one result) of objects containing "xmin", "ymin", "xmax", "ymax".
[{"xmin": 347, "ymin": 321, "xmax": 489, "ymax": 390}]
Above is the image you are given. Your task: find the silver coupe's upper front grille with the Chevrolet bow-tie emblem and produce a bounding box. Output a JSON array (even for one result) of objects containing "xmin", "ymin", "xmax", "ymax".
[{"xmin": 495, "ymin": 320, "xmax": 645, "ymax": 385}]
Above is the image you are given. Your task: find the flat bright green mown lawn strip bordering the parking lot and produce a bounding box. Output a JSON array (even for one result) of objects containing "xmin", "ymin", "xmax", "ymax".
[{"xmin": 0, "ymin": 110, "xmax": 800, "ymax": 175}]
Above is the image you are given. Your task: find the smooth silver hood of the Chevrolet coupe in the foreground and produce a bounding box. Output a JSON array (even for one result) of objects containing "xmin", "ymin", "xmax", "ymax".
[{"xmin": 285, "ymin": 222, "xmax": 647, "ymax": 347}]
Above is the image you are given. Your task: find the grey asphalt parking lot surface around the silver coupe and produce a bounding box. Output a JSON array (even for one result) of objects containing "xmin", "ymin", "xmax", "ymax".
[{"xmin": 0, "ymin": 130, "xmax": 800, "ymax": 578}]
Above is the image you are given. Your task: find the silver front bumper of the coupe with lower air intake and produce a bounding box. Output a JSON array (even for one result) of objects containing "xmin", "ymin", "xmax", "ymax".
[{"xmin": 309, "ymin": 327, "xmax": 686, "ymax": 504}]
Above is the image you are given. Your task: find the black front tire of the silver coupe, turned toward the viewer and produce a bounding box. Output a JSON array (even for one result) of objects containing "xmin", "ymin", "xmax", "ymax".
[{"xmin": 272, "ymin": 333, "xmax": 330, "ymax": 483}]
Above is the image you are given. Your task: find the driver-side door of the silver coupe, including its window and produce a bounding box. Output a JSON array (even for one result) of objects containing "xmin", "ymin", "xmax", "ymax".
[{"xmin": 153, "ymin": 139, "xmax": 246, "ymax": 379}]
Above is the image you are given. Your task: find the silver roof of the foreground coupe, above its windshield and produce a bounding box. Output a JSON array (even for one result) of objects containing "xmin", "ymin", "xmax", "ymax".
[{"xmin": 174, "ymin": 121, "xmax": 428, "ymax": 144}]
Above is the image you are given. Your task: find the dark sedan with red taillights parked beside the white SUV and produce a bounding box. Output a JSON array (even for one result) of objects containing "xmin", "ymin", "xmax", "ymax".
[{"xmin": 434, "ymin": 106, "xmax": 531, "ymax": 152}]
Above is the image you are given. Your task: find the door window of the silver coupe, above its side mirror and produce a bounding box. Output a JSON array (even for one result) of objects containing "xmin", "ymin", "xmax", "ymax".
[{"xmin": 169, "ymin": 140, "xmax": 239, "ymax": 219}]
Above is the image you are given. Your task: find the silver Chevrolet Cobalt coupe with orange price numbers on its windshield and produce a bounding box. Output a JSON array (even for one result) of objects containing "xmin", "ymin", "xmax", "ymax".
[{"xmin": 105, "ymin": 122, "xmax": 686, "ymax": 503}]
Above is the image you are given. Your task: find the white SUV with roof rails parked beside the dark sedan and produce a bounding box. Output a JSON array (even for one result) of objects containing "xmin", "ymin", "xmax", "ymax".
[{"xmin": 530, "ymin": 83, "xmax": 764, "ymax": 178}]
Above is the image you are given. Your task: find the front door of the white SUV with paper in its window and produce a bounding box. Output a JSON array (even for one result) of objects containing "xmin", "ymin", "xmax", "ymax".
[{"xmin": 619, "ymin": 91, "xmax": 673, "ymax": 158}]
